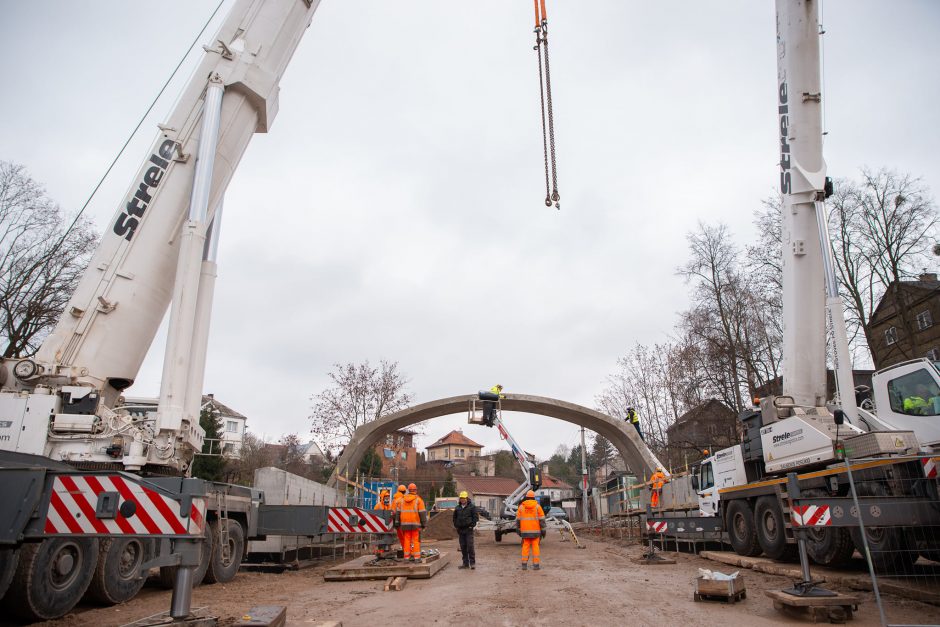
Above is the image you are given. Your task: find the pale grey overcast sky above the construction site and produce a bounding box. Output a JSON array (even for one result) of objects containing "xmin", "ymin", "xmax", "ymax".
[{"xmin": 0, "ymin": 0, "xmax": 940, "ymax": 457}]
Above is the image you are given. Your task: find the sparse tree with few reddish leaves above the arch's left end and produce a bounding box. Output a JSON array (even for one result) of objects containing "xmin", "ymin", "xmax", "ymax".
[{"xmin": 310, "ymin": 360, "xmax": 411, "ymax": 448}]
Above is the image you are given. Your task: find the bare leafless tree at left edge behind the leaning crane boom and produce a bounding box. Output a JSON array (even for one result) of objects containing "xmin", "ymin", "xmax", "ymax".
[{"xmin": 0, "ymin": 161, "xmax": 98, "ymax": 358}]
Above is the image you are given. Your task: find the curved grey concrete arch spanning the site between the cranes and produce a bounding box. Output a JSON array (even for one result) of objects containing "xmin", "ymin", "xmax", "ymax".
[{"xmin": 329, "ymin": 394, "xmax": 661, "ymax": 487}]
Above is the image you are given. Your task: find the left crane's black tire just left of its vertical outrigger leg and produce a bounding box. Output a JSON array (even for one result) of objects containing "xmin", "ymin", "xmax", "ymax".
[{"xmin": 88, "ymin": 538, "xmax": 153, "ymax": 605}]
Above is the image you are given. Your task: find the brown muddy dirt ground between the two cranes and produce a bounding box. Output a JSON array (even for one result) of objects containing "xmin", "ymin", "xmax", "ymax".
[{"xmin": 33, "ymin": 532, "xmax": 940, "ymax": 627}]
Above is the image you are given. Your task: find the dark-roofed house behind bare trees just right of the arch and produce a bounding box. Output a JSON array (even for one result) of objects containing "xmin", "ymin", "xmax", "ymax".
[{"xmin": 663, "ymin": 399, "xmax": 743, "ymax": 468}]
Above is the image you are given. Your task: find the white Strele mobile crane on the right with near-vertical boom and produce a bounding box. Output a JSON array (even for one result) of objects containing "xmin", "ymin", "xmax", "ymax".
[{"xmin": 648, "ymin": 0, "xmax": 940, "ymax": 588}]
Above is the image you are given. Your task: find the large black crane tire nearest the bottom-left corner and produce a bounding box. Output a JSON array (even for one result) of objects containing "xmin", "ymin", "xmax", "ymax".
[{"xmin": 6, "ymin": 538, "xmax": 98, "ymax": 622}]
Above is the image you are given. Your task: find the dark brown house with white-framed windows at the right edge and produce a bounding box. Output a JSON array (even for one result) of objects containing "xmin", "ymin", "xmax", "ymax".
[{"xmin": 868, "ymin": 273, "xmax": 940, "ymax": 369}]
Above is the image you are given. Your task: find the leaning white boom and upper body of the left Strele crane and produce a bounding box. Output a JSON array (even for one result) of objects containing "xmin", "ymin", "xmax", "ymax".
[{"xmin": 0, "ymin": 0, "xmax": 320, "ymax": 470}]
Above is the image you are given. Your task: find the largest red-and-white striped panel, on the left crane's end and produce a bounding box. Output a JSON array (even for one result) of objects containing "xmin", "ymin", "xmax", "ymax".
[{"xmin": 45, "ymin": 475, "xmax": 206, "ymax": 536}]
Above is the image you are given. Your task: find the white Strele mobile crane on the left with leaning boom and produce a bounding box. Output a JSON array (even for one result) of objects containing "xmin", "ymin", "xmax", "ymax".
[{"xmin": 0, "ymin": 0, "xmax": 400, "ymax": 620}]
